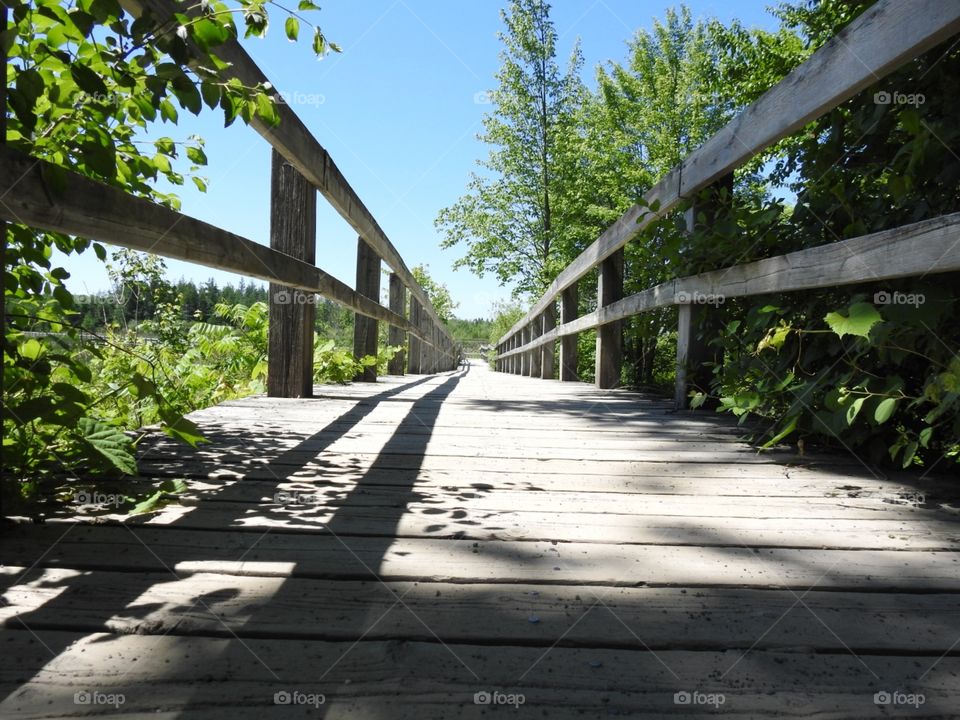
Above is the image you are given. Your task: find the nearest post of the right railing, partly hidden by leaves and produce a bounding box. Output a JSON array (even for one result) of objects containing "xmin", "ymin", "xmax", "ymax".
[{"xmin": 673, "ymin": 173, "xmax": 733, "ymax": 410}]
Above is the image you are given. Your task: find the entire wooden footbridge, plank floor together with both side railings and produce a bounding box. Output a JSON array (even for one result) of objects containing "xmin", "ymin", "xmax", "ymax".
[{"xmin": 0, "ymin": 0, "xmax": 960, "ymax": 720}]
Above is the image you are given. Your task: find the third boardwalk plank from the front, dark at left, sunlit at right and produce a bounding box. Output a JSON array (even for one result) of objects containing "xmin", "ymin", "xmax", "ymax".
[{"xmin": 7, "ymin": 525, "xmax": 960, "ymax": 592}]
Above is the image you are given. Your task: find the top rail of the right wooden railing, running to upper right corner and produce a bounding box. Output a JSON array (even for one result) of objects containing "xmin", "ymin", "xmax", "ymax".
[{"xmin": 504, "ymin": 0, "xmax": 960, "ymax": 346}]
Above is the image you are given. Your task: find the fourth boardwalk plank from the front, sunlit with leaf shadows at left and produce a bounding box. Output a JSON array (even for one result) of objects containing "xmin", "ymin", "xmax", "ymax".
[{"xmin": 80, "ymin": 500, "xmax": 960, "ymax": 551}]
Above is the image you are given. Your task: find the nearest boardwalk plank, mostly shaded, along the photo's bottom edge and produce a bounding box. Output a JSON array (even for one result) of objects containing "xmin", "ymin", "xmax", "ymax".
[{"xmin": 0, "ymin": 628, "xmax": 960, "ymax": 720}]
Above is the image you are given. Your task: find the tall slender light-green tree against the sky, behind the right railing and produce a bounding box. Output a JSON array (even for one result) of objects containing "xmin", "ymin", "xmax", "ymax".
[{"xmin": 436, "ymin": 0, "xmax": 585, "ymax": 293}]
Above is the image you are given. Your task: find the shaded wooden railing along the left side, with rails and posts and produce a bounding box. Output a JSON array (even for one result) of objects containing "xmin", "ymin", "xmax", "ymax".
[{"xmin": 0, "ymin": 0, "xmax": 460, "ymax": 397}]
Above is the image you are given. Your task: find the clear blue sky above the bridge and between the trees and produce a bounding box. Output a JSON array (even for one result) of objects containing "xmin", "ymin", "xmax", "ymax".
[{"xmin": 58, "ymin": 0, "xmax": 776, "ymax": 318}]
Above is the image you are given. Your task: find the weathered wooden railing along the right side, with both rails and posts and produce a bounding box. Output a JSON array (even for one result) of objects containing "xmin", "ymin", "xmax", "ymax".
[{"xmin": 495, "ymin": 0, "xmax": 960, "ymax": 407}]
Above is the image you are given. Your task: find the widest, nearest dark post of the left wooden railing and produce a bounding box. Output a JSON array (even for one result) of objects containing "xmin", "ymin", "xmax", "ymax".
[{"xmin": 267, "ymin": 150, "xmax": 317, "ymax": 397}]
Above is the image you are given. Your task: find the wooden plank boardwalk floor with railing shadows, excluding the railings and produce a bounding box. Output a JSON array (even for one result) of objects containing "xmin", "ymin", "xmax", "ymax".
[{"xmin": 0, "ymin": 363, "xmax": 960, "ymax": 720}]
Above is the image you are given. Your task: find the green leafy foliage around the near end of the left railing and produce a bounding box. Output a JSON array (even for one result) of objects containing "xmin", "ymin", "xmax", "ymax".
[{"xmin": 0, "ymin": 0, "xmax": 338, "ymax": 516}]
